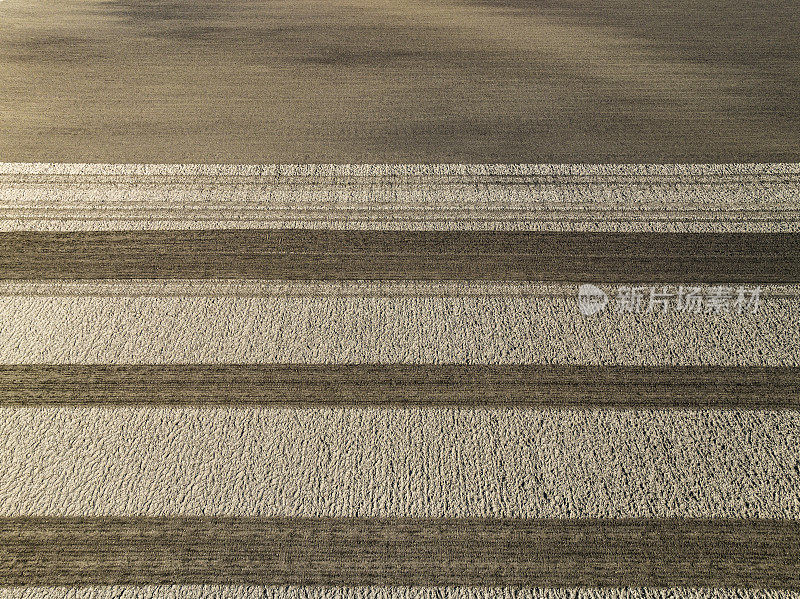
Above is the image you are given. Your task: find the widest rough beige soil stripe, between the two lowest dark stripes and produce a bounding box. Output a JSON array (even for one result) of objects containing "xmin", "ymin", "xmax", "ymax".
[{"xmin": 0, "ymin": 406, "xmax": 800, "ymax": 520}]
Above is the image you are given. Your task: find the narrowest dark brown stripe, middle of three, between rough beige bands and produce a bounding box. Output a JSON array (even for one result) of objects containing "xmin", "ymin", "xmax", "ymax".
[{"xmin": 0, "ymin": 365, "xmax": 800, "ymax": 409}]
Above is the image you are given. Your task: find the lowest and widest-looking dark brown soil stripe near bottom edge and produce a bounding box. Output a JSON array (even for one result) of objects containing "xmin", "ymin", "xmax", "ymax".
[{"xmin": 0, "ymin": 517, "xmax": 800, "ymax": 589}]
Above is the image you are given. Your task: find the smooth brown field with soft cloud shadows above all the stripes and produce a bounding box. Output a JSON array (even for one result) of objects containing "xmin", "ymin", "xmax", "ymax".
[{"xmin": 0, "ymin": 0, "xmax": 800, "ymax": 163}]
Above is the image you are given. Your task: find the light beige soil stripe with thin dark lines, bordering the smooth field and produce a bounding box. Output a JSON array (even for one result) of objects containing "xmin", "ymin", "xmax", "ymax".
[{"xmin": 0, "ymin": 163, "xmax": 800, "ymax": 232}]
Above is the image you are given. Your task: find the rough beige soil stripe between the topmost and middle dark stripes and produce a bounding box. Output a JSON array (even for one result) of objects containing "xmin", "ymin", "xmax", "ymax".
[{"xmin": 0, "ymin": 295, "xmax": 800, "ymax": 366}]
